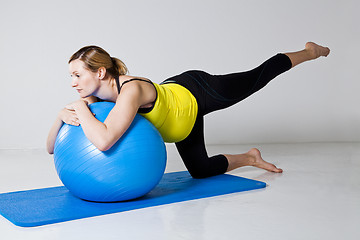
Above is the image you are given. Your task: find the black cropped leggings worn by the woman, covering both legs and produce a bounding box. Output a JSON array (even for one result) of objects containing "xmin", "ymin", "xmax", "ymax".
[{"xmin": 162, "ymin": 54, "xmax": 291, "ymax": 178}]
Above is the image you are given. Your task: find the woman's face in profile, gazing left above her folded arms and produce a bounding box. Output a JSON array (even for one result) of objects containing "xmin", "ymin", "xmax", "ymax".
[{"xmin": 69, "ymin": 59, "xmax": 99, "ymax": 98}]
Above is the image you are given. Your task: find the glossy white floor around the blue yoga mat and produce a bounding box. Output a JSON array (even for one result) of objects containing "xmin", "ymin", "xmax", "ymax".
[{"xmin": 0, "ymin": 143, "xmax": 360, "ymax": 240}]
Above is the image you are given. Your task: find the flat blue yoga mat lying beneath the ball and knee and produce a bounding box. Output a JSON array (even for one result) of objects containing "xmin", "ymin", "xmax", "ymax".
[{"xmin": 0, "ymin": 171, "xmax": 266, "ymax": 227}]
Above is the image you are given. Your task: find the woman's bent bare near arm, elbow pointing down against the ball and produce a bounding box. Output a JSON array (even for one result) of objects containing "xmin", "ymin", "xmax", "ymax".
[{"xmin": 71, "ymin": 84, "xmax": 144, "ymax": 151}]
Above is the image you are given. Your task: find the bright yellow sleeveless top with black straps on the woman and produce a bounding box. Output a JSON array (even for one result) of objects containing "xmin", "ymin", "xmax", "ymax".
[{"xmin": 116, "ymin": 78, "xmax": 198, "ymax": 143}]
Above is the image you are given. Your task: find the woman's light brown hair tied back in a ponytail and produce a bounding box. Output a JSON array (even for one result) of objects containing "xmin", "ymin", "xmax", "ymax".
[{"xmin": 69, "ymin": 46, "xmax": 128, "ymax": 78}]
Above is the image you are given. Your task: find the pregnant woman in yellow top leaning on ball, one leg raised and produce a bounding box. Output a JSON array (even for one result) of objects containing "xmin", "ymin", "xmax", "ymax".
[{"xmin": 47, "ymin": 42, "xmax": 330, "ymax": 178}]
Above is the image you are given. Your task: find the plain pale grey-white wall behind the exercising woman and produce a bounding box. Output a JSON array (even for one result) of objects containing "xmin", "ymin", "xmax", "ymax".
[{"xmin": 0, "ymin": 0, "xmax": 360, "ymax": 148}]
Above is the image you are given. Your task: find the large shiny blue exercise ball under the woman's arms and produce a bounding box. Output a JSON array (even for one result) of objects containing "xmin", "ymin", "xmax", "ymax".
[{"xmin": 54, "ymin": 102, "xmax": 166, "ymax": 202}]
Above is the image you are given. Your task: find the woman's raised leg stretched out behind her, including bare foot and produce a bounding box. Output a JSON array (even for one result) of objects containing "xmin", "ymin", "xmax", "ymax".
[{"xmin": 191, "ymin": 42, "xmax": 330, "ymax": 115}]
